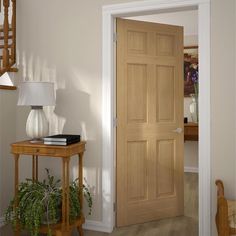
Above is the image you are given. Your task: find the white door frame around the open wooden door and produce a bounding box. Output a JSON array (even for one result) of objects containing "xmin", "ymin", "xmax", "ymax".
[{"xmin": 102, "ymin": 0, "xmax": 211, "ymax": 236}]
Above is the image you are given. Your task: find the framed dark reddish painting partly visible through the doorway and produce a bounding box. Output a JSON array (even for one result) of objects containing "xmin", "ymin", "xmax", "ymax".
[{"xmin": 184, "ymin": 46, "xmax": 198, "ymax": 97}]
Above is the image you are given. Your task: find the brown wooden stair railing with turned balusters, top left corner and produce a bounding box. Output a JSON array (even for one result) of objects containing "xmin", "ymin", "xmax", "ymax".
[{"xmin": 0, "ymin": 0, "xmax": 18, "ymax": 76}]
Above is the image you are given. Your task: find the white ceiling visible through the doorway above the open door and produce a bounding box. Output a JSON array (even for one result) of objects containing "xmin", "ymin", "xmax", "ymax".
[{"xmin": 126, "ymin": 10, "xmax": 198, "ymax": 36}]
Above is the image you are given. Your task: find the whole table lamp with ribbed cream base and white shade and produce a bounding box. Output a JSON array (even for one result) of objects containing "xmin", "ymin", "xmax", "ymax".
[{"xmin": 17, "ymin": 82, "xmax": 55, "ymax": 143}]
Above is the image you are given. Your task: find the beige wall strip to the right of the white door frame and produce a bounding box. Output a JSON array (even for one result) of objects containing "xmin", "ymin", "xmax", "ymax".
[{"xmin": 211, "ymin": 0, "xmax": 236, "ymax": 235}]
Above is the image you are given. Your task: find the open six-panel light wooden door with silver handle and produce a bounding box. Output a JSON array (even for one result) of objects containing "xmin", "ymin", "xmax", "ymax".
[{"xmin": 117, "ymin": 19, "xmax": 184, "ymax": 226}]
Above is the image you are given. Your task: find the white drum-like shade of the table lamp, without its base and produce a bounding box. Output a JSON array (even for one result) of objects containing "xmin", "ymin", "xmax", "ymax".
[{"xmin": 17, "ymin": 82, "xmax": 55, "ymax": 106}]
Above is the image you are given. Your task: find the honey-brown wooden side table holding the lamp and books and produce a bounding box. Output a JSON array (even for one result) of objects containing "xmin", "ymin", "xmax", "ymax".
[{"xmin": 11, "ymin": 141, "xmax": 86, "ymax": 236}]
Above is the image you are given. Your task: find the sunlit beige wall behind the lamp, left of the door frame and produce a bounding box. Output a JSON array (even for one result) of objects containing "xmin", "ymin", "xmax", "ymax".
[{"xmin": 8, "ymin": 0, "xmax": 144, "ymax": 221}]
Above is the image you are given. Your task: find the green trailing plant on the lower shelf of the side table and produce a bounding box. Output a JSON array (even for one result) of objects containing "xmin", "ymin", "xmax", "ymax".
[{"xmin": 5, "ymin": 169, "xmax": 92, "ymax": 236}]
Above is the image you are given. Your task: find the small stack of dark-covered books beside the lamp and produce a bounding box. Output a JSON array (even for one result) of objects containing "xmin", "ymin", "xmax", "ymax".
[{"xmin": 43, "ymin": 134, "xmax": 80, "ymax": 146}]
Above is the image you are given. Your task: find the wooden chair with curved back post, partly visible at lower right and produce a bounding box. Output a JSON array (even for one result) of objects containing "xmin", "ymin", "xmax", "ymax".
[{"xmin": 215, "ymin": 180, "xmax": 236, "ymax": 236}]
